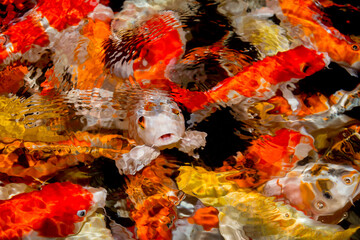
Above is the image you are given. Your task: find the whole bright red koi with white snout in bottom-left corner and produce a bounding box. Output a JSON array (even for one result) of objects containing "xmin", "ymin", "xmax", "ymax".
[{"xmin": 0, "ymin": 182, "xmax": 106, "ymax": 240}]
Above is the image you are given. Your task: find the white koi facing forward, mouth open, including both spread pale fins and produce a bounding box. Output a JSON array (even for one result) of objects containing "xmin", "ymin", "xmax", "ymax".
[{"xmin": 116, "ymin": 91, "xmax": 207, "ymax": 174}]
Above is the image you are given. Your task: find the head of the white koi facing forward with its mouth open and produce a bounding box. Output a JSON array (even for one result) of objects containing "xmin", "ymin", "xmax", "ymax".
[{"xmin": 129, "ymin": 96, "xmax": 185, "ymax": 148}]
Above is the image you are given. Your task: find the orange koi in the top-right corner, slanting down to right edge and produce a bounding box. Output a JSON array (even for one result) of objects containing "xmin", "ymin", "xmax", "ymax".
[{"xmin": 279, "ymin": 0, "xmax": 360, "ymax": 70}]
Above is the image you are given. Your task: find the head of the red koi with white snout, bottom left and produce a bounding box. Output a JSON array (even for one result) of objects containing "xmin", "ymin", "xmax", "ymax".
[{"xmin": 33, "ymin": 182, "xmax": 106, "ymax": 237}]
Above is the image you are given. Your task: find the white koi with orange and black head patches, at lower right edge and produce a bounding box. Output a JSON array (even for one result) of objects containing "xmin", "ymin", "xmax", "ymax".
[{"xmin": 263, "ymin": 163, "xmax": 360, "ymax": 219}]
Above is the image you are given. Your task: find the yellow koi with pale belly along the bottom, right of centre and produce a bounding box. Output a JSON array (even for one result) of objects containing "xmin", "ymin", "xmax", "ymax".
[{"xmin": 176, "ymin": 166, "xmax": 358, "ymax": 240}]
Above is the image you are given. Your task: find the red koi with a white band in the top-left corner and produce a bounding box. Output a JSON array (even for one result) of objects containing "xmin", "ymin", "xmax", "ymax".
[{"xmin": 0, "ymin": 0, "xmax": 98, "ymax": 64}]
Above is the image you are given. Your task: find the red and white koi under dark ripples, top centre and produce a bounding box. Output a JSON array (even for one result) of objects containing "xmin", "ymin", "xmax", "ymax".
[{"xmin": 104, "ymin": 11, "xmax": 185, "ymax": 82}]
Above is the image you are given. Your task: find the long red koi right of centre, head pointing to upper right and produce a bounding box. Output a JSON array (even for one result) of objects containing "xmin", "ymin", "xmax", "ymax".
[{"xmin": 140, "ymin": 46, "xmax": 326, "ymax": 112}]
